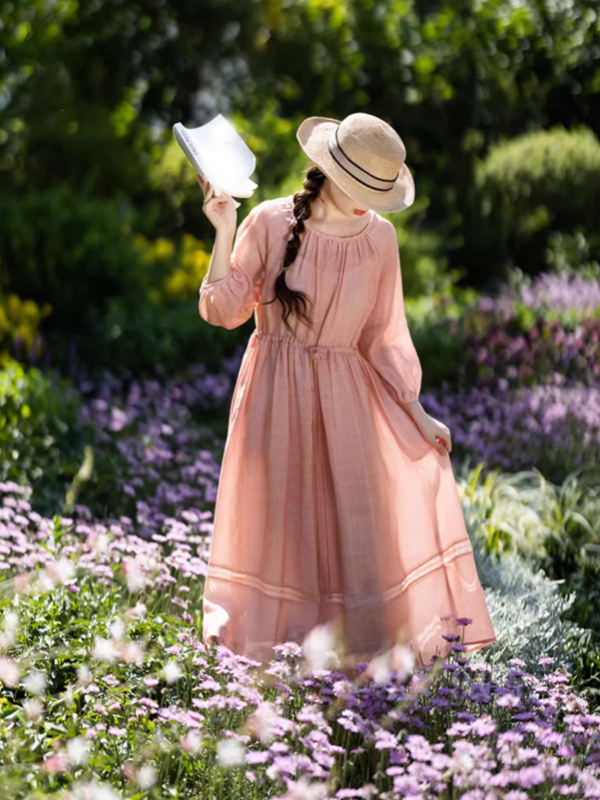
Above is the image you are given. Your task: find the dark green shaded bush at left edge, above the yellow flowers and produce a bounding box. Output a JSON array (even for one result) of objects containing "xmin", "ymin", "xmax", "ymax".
[{"xmin": 0, "ymin": 186, "xmax": 145, "ymax": 332}]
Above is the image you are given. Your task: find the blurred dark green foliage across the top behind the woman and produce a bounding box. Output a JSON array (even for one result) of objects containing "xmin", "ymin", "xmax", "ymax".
[{"xmin": 0, "ymin": 0, "xmax": 600, "ymax": 378}]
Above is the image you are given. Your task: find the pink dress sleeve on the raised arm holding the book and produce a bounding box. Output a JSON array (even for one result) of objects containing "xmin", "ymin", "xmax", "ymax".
[{"xmin": 198, "ymin": 203, "xmax": 267, "ymax": 329}]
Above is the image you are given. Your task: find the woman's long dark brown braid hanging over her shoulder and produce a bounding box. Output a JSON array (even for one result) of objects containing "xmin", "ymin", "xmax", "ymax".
[{"xmin": 260, "ymin": 166, "xmax": 325, "ymax": 331}]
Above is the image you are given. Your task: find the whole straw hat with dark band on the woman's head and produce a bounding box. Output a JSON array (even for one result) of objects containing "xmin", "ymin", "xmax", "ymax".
[{"xmin": 296, "ymin": 112, "xmax": 415, "ymax": 213}]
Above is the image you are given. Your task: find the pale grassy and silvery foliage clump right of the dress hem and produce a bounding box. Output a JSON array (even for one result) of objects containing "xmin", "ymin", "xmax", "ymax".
[{"xmin": 457, "ymin": 464, "xmax": 600, "ymax": 691}]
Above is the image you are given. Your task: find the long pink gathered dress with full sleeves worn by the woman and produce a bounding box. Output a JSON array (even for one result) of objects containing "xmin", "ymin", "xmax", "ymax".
[{"xmin": 199, "ymin": 195, "xmax": 496, "ymax": 664}]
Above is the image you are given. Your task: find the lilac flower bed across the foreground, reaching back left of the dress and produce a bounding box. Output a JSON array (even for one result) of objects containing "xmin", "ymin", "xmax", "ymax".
[{"xmin": 0, "ymin": 338, "xmax": 600, "ymax": 800}]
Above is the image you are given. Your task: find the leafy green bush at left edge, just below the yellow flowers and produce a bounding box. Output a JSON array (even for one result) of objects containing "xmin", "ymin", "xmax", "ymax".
[{"xmin": 0, "ymin": 361, "xmax": 92, "ymax": 514}]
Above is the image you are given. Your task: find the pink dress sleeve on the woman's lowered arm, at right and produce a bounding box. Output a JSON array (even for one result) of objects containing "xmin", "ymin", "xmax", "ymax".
[{"xmin": 358, "ymin": 222, "xmax": 422, "ymax": 403}]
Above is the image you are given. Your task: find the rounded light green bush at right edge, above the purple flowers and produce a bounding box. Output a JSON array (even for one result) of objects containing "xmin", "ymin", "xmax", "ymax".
[{"xmin": 465, "ymin": 126, "xmax": 600, "ymax": 281}]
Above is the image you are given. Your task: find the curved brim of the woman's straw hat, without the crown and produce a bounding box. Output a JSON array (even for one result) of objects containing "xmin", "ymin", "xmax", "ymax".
[{"xmin": 296, "ymin": 117, "xmax": 415, "ymax": 214}]
